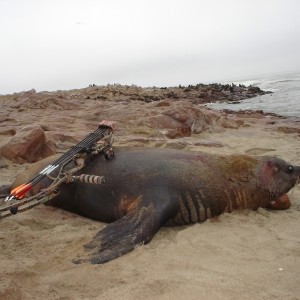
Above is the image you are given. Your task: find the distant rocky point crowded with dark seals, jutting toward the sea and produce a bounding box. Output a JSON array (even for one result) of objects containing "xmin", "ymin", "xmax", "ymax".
[{"xmin": 71, "ymin": 83, "xmax": 270, "ymax": 104}]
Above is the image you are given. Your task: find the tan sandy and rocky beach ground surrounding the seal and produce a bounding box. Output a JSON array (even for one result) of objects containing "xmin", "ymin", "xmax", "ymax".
[{"xmin": 0, "ymin": 87, "xmax": 300, "ymax": 300}]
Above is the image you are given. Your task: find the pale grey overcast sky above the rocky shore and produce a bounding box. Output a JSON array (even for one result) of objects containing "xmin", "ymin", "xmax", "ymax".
[{"xmin": 0, "ymin": 0, "xmax": 300, "ymax": 94}]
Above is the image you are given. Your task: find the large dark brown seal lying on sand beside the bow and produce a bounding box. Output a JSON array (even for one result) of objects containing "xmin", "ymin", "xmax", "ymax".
[{"xmin": 4, "ymin": 149, "xmax": 300, "ymax": 264}]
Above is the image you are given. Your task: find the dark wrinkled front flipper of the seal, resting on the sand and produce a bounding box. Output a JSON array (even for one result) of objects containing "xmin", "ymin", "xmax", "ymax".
[{"xmin": 73, "ymin": 203, "xmax": 161, "ymax": 264}]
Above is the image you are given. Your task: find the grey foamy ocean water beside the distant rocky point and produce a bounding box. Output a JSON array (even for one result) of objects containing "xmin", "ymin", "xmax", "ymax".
[{"xmin": 207, "ymin": 72, "xmax": 300, "ymax": 117}]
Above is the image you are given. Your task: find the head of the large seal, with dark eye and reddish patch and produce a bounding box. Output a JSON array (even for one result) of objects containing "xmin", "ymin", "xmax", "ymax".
[{"xmin": 261, "ymin": 158, "xmax": 300, "ymax": 209}]
